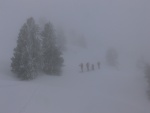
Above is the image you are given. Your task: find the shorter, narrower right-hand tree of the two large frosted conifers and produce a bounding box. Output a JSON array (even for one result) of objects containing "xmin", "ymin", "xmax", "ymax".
[{"xmin": 41, "ymin": 23, "xmax": 63, "ymax": 75}]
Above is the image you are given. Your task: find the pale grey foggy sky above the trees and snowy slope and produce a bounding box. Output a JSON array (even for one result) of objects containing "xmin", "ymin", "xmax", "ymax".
[{"xmin": 0, "ymin": 0, "xmax": 150, "ymax": 60}]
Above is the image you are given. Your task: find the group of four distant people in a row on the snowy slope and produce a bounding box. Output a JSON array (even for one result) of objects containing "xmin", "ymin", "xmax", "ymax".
[{"xmin": 79, "ymin": 62, "xmax": 100, "ymax": 72}]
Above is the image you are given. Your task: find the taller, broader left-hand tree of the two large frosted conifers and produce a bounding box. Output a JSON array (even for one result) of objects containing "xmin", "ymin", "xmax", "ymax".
[{"xmin": 11, "ymin": 17, "xmax": 40, "ymax": 79}]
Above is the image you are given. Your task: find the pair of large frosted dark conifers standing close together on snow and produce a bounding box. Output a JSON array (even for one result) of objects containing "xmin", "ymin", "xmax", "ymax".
[{"xmin": 11, "ymin": 17, "xmax": 64, "ymax": 80}]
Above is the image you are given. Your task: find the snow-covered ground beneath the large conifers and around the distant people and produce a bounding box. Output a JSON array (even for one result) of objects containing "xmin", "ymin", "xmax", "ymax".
[{"xmin": 0, "ymin": 48, "xmax": 150, "ymax": 113}]
